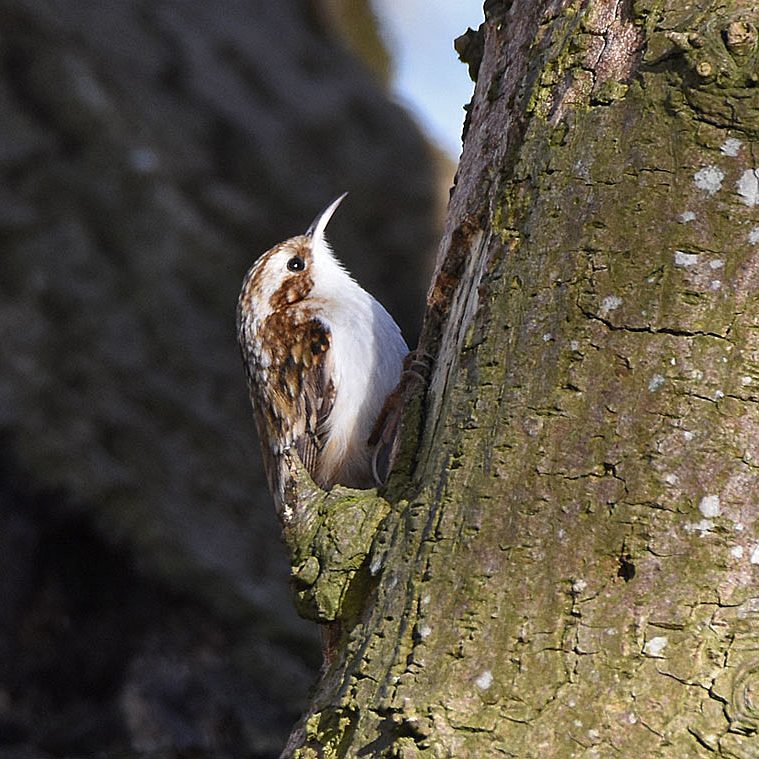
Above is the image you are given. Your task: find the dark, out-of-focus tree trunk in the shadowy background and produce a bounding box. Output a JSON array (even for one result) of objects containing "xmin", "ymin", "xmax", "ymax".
[{"xmin": 0, "ymin": 0, "xmax": 439, "ymax": 759}]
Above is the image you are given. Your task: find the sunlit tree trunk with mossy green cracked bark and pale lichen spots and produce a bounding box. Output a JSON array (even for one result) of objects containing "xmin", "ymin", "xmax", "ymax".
[{"xmin": 286, "ymin": 0, "xmax": 759, "ymax": 757}]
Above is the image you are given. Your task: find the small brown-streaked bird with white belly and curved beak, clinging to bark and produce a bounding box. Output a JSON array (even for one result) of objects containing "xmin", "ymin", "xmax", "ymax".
[{"xmin": 236, "ymin": 193, "xmax": 409, "ymax": 501}]
